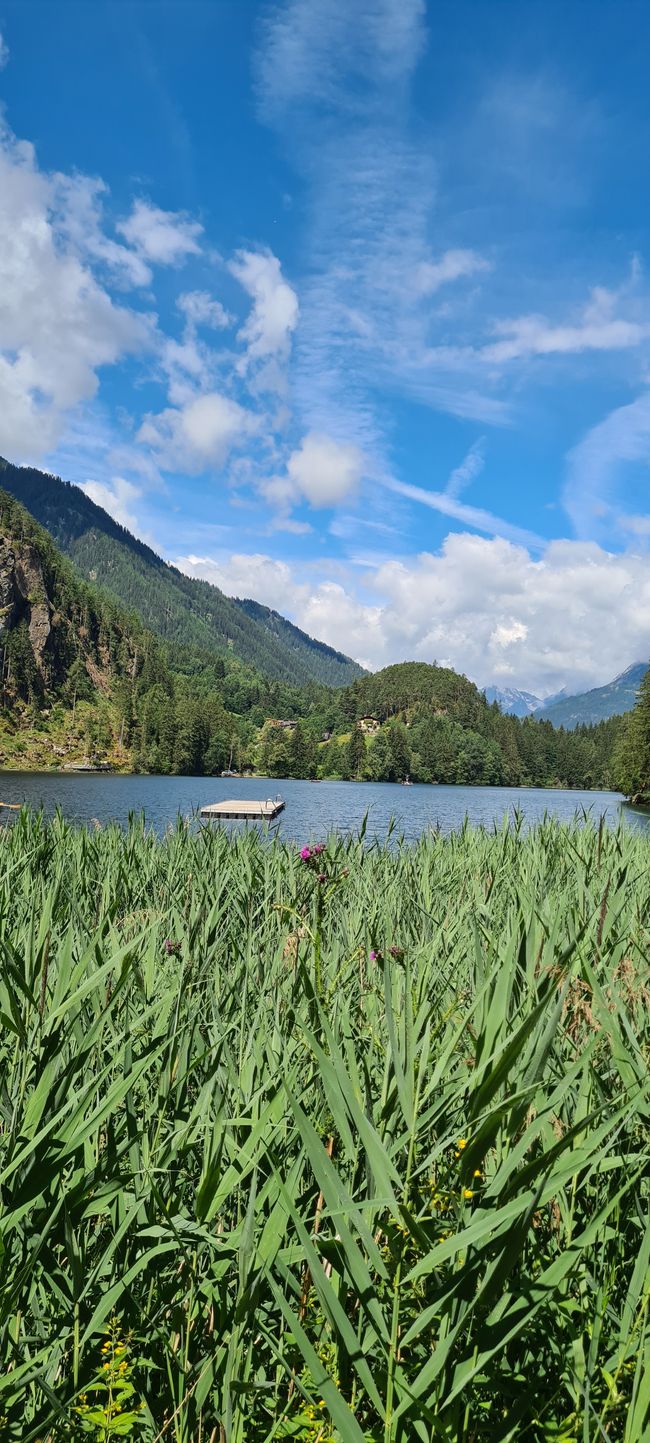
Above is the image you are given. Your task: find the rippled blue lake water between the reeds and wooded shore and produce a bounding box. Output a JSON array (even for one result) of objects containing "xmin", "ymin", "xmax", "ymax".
[{"xmin": 0, "ymin": 772, "xmax": 650, "ymax": 841}]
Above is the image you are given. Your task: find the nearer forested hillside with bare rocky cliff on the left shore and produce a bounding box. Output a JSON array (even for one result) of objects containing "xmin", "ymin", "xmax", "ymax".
[{"xmin": 0, "ymin": 491, "xmax": 323, "ymax": 773}]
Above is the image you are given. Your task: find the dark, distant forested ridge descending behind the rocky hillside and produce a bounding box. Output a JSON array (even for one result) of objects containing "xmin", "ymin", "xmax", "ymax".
[{"xmin": 0, "ymin": 457, "xmax": 364, "ymax": 687}]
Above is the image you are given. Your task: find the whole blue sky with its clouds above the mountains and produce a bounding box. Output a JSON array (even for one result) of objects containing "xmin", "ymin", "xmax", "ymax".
[{"xmin": 0, "ymin": 0, "xmax": 650, "ymax": 694}]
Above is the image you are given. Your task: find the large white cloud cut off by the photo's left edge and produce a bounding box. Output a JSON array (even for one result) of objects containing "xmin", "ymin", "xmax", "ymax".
[{"xmin": 0, "ymin": 128, "xmax": 152, "ymax": 460}]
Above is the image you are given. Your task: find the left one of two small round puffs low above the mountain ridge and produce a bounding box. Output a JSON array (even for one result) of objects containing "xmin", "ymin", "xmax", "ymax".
[{"xmin": 137, "ymin": 391, "xmax": 259, "ymax": 472}]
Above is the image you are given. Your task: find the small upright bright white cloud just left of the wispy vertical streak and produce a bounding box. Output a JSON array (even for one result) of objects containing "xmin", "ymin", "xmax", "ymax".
[{"xmin": 228, "ymin": 251, "xmax": 299, "ymax": 361}]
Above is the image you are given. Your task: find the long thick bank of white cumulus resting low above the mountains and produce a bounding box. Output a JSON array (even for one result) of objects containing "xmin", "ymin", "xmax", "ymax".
[{"xmin": 178, "ymin": 532, "xmax": 650, "ymax": 696}]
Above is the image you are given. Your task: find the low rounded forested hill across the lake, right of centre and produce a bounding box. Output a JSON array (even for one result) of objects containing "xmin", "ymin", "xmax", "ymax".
[{"xmin": 259, "ymin": 661, "xmax": 621, "ymax": 788}]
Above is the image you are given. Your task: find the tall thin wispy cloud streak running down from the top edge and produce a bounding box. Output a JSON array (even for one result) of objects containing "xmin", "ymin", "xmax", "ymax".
[{"xmin": 257, "ymin": 0, "xmax": 501, "ymax": 473}]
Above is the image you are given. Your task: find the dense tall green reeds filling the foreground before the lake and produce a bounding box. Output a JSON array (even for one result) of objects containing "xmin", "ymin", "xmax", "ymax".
[{"xmin": 0, "ymin": 817, "xmax": 650, "ymax": 1443}]
